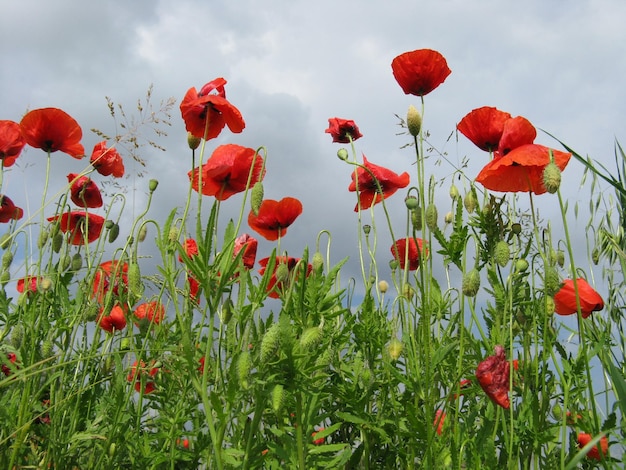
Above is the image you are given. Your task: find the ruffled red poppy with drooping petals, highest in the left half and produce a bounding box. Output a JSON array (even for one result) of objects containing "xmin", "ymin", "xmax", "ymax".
[{"xmin": 180, "ymin": 78, "xmax": 246, "ymax": 140}]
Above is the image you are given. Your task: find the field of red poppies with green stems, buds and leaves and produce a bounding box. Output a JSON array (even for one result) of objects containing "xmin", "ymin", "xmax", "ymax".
[{"xmin": 0, "ymin": 49, "xmax": 626, "ymax": 469}]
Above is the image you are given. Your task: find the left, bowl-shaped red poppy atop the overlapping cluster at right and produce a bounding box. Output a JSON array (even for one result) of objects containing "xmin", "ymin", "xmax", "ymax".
[{"xmin": 456, "ymin": 106, "xmax": 511, "ymax": 152}]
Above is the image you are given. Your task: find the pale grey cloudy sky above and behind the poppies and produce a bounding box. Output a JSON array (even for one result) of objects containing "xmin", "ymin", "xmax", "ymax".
[{"xmin": 0, "ymin": 0, "xmax": 626, "ymax": 294}]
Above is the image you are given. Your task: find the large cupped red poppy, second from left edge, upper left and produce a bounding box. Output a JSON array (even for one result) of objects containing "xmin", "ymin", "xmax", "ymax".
[{"xmin": 20, "ymin": 108, "xmax": 85, "ymax": 159}]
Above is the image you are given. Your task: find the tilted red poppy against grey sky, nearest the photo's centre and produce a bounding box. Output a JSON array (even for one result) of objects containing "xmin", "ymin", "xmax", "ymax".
[{"xmin": 248, "ymin": 197, "xmax": 302, "ymax": 241}]
